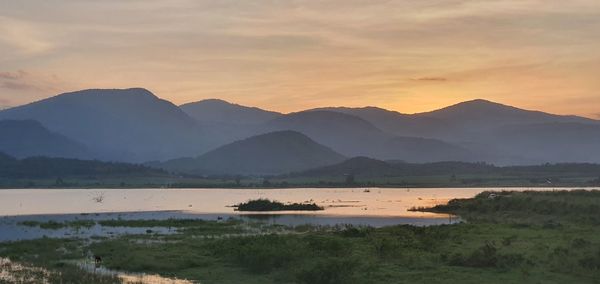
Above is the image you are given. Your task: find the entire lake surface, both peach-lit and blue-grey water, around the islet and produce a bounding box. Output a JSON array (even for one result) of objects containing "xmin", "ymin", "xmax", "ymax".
[{"xmin": 0, "ymin": 188, "xmax": 592, "ymax": 241}]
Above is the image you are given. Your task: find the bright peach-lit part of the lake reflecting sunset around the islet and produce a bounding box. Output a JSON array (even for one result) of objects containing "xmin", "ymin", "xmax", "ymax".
[{"xmin": 0, "ymin": 188, "xmax": 588, "ymax": 218}]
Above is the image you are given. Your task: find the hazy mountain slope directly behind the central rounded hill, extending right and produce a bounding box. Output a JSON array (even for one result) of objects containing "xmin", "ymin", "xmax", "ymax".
[{"xmin": 265, "ymin": 111, "xmax": 474, "ymax": 162}]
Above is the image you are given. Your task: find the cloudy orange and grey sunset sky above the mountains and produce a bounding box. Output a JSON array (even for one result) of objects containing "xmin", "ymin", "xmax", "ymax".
[{"xmin": 0, "ymin": 0, "xmax": 600, "ymax": 118}]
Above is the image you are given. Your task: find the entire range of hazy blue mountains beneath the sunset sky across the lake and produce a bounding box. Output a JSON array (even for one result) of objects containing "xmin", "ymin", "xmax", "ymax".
[{"xmin": 0, "ymin": 88, "xmax": 600, "ymax": 174}]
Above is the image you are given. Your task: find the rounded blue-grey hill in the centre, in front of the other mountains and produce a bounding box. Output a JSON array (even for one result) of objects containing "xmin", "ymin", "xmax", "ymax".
[{"xmin": 153, "ymin": 131, "xmax": 345, "ymax": 175}]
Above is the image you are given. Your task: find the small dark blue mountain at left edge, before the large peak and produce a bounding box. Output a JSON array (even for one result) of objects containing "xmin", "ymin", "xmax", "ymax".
[{"xmin": 0, "ymin": 120, "xmax": 92, "ymax": 158}]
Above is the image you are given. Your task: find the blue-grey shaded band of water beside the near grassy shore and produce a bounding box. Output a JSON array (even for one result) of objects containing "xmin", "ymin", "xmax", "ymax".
[{"xmin": 0, "ymin": 211, "xmax": 459, "ymax": 242}]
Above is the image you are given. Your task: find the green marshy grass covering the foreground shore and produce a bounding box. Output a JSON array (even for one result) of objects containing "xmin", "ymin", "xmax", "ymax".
[{"xmin": 0, "ymin": 191, "xmax": 600, "ymax": 284}]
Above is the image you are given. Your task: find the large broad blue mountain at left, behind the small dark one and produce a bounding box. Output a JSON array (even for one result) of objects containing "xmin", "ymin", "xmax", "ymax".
[{"xmin": 0, "ymin": 88, "xmax": 205, "ymax": 161}]
